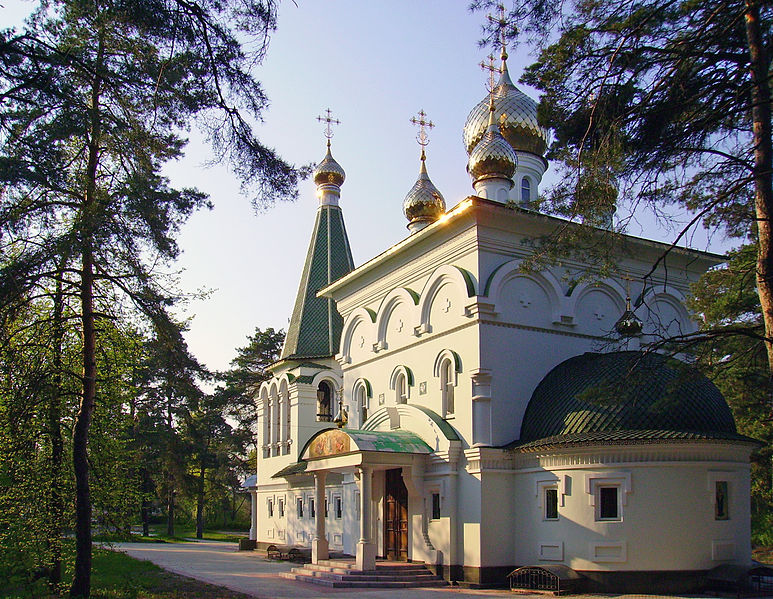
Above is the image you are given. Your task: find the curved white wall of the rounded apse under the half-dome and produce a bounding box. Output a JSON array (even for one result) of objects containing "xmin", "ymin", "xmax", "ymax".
[{"xmin": 510, "ymin": 443, "xmax": 751, "ymax": 571}]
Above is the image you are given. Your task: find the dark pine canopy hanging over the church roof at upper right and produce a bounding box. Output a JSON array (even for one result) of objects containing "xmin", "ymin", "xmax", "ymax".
[{"xmin": 473, "ymin": 0, "xmax": 773, "ymax": 388}]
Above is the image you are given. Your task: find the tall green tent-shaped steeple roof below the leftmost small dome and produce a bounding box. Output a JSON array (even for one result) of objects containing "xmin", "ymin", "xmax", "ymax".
[{"xmin": 280, "ymin": 206, "xmax": 354, "ymax": 360}]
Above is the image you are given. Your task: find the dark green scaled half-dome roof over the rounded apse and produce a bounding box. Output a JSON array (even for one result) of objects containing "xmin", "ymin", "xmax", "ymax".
[{"xmin": 517, "ymin": 351, "xmax": 746, "ymax": 446}]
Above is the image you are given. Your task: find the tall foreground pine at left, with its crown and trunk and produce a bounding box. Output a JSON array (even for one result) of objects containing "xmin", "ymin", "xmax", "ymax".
[{"xmin": 0, "ymin": 0, "xmax": 299, "ymax": 597}]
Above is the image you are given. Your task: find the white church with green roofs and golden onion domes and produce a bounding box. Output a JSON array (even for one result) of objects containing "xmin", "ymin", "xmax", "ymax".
[{"xmin": 250, "ymin": 43, "xmax": 755, "ymax": 591}]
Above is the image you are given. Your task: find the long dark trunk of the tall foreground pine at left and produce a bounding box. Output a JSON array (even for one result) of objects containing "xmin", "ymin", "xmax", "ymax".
[{"xmin": 70, "ymin": 36, "xmax": 104, "ymax": 597}]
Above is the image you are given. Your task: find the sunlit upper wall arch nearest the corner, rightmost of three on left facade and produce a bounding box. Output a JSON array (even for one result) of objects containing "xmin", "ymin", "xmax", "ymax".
[{"xmin": 416, "ymin": 264, "xmax": 476, "ymax": 334}]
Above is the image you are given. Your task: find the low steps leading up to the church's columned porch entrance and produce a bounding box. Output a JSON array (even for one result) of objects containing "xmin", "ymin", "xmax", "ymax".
[{"xmin": 279, "ymin": 560, "xmax": 448, "ymax": 589}]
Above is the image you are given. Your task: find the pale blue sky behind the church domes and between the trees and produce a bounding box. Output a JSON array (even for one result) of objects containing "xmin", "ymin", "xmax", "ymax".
[{"xmin": 0, "ymin": 0, "xmax": 724, "ymax": 376}]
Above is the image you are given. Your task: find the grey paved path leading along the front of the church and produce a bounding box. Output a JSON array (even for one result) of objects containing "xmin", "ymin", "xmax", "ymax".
[{"xmin": 113, "ymin": 541, "xmax": 720, "ymax": 599}]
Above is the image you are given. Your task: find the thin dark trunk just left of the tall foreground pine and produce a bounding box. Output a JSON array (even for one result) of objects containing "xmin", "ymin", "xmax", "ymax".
[{"xmin": 46, "ymin": 260, "xmax": 65, "ymax": 595}]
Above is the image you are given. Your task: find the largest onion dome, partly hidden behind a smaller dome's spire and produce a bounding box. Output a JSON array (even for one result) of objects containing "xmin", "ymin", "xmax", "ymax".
[{"xmin": 463, "ymin": 60, "xmax": 548, "ymax": 156}]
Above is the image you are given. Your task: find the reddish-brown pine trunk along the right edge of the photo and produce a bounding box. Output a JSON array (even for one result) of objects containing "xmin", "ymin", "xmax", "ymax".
[{"xmin": 744, "ymin": 0, "xmax": 773, "ymax": 407}]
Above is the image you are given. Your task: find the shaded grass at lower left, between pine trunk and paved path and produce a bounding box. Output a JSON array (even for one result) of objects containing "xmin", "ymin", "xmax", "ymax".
[{"xmin": 6, "ymin": 547, "xmax": 249, "ymax": 599}]
